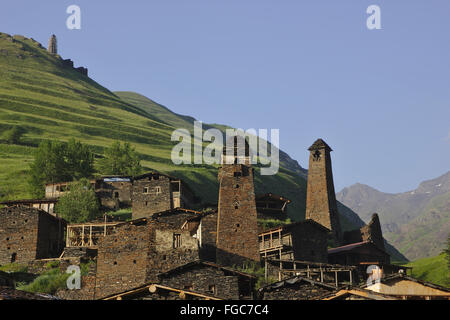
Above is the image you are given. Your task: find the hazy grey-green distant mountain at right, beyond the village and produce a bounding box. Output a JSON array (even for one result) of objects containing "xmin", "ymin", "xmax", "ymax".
[{"xmin": 336, "ymin": 171, "xmax": 450, "ymax": 260}]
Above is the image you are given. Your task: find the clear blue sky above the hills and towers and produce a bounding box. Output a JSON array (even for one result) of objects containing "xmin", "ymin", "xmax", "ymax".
[{"xmin": 0, "ymin": 0, "xmax": 450, "ymax": 192}]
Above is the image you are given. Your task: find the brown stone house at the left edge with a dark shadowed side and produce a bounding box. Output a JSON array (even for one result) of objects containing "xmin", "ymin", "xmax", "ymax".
[{"xmin": 0, "ymin": 206, "xmax": 66, "ymax": 265}]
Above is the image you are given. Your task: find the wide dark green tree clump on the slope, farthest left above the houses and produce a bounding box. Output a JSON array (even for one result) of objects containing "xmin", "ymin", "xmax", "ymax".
[{"xmin": 29, "ymin": 139, "xmax": 94, "ymax": 198}]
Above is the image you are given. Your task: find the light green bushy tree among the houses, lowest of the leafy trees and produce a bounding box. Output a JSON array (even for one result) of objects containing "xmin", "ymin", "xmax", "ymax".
[{"xmin": 55, "ymin": 179, "xmax": 101, "ymax": 223}]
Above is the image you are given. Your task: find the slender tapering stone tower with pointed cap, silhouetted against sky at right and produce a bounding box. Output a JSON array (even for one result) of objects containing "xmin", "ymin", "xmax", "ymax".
[{"xmin": 306, "ymin": 139, "xmax": 342, "ymax": 244}]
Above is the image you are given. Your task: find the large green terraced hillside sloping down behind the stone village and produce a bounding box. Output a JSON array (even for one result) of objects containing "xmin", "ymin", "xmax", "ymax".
[{"xmin": 0, "ymin": 33, "xmax": 406, "ymax": 262}]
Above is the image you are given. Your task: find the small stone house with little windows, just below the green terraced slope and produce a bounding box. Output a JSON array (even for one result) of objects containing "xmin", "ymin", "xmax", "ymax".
[{"xmin": 132, "ymin": 172, "xmax": 195, "ymax": 219}]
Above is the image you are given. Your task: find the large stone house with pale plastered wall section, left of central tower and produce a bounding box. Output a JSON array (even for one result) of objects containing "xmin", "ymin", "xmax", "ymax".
[{"xmin": 95, "ymin": 210, "xmax": 199, "ymax": 298}]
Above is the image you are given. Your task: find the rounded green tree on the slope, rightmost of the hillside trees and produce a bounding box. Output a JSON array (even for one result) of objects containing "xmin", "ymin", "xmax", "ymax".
[{"xmin": 100, "ymin": 141, "xmax": 142, "ymax": 176}]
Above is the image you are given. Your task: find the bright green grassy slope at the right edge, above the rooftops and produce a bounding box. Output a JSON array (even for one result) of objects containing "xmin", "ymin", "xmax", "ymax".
[{"xmin": 405, "ymin": 253, "xmax": 450, "ymax": 288}]
